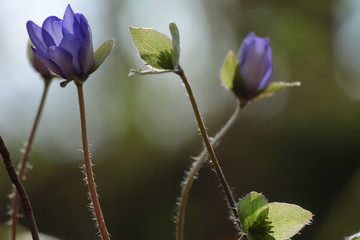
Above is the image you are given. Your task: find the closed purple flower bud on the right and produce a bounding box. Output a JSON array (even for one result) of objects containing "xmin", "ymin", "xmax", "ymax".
[{"xmin": 237, "ymin": 32, "xmax": 273, "ymax": 100}]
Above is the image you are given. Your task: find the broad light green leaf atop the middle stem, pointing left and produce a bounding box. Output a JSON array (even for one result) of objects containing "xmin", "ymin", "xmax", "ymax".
[{"xmin": 129, "ymin": 27, "xmax": 176, "ymax": 70}]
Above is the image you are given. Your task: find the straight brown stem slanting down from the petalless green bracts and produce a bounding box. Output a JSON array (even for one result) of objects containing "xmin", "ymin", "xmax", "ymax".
[{"xmin": 176, "ymin": 66, "xmax": 241, "ymax": 232}]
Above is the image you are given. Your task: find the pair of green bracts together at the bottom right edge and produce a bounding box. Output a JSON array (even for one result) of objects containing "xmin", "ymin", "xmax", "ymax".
[{"xmin": 238, "ymin": 192, "xmax": 312, "ymax": 240}]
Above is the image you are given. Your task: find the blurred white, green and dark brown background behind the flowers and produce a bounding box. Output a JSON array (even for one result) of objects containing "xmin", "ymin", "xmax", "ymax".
[{"xmin": 0, "ymin": 0, "xmax": 360, "ymax": 240}]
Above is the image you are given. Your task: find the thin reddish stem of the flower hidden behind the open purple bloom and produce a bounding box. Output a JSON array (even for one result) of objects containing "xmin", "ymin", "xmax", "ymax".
[{"xmin": 11, "ymin": 79, "xmax": 51, "ymax": 240}]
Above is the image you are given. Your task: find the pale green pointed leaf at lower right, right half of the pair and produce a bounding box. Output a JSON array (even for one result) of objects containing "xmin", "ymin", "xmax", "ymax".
[{"xmin": 268, "ymin": 203, "xmax": 313, "ymax": 240}]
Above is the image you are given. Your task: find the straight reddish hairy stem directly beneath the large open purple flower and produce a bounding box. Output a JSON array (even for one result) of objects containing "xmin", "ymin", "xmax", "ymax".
[{"xmin": 74, "ymin": 80, "xmax": 110, "ymax": 240}]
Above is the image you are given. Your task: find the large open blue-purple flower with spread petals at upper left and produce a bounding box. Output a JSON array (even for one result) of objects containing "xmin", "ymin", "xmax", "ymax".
[{"xmin": 26, "ymin": 5, "xmax": 95, "ymax": 81}]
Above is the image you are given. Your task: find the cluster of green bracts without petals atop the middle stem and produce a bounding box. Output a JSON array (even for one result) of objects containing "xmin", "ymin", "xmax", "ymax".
[{"xmin": 130, "ymin": 23, "xmax": 180, "ymax": 75}]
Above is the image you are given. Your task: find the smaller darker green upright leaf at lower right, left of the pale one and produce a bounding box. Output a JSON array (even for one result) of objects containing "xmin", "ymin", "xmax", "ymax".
[{"xmin": 238, "ymin": 192, "xmax": 269, "ymax": 234}]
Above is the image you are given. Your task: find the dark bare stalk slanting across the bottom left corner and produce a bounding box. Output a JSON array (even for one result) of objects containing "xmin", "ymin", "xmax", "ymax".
[{"xmin": 0, "ymin": 136, "xmax": 39, "ymax": 240}]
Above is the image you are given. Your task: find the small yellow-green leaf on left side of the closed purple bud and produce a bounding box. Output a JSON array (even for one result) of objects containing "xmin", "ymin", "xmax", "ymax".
[{"xmin": 220, "ymin": 51, "xmax": 239, "ymax": 89}]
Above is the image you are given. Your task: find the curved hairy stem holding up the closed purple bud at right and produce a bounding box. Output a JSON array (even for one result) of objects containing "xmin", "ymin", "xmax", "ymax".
[{"xmin": 176, "ymin": 100, "xmax": 245, "ymax": 240}]
